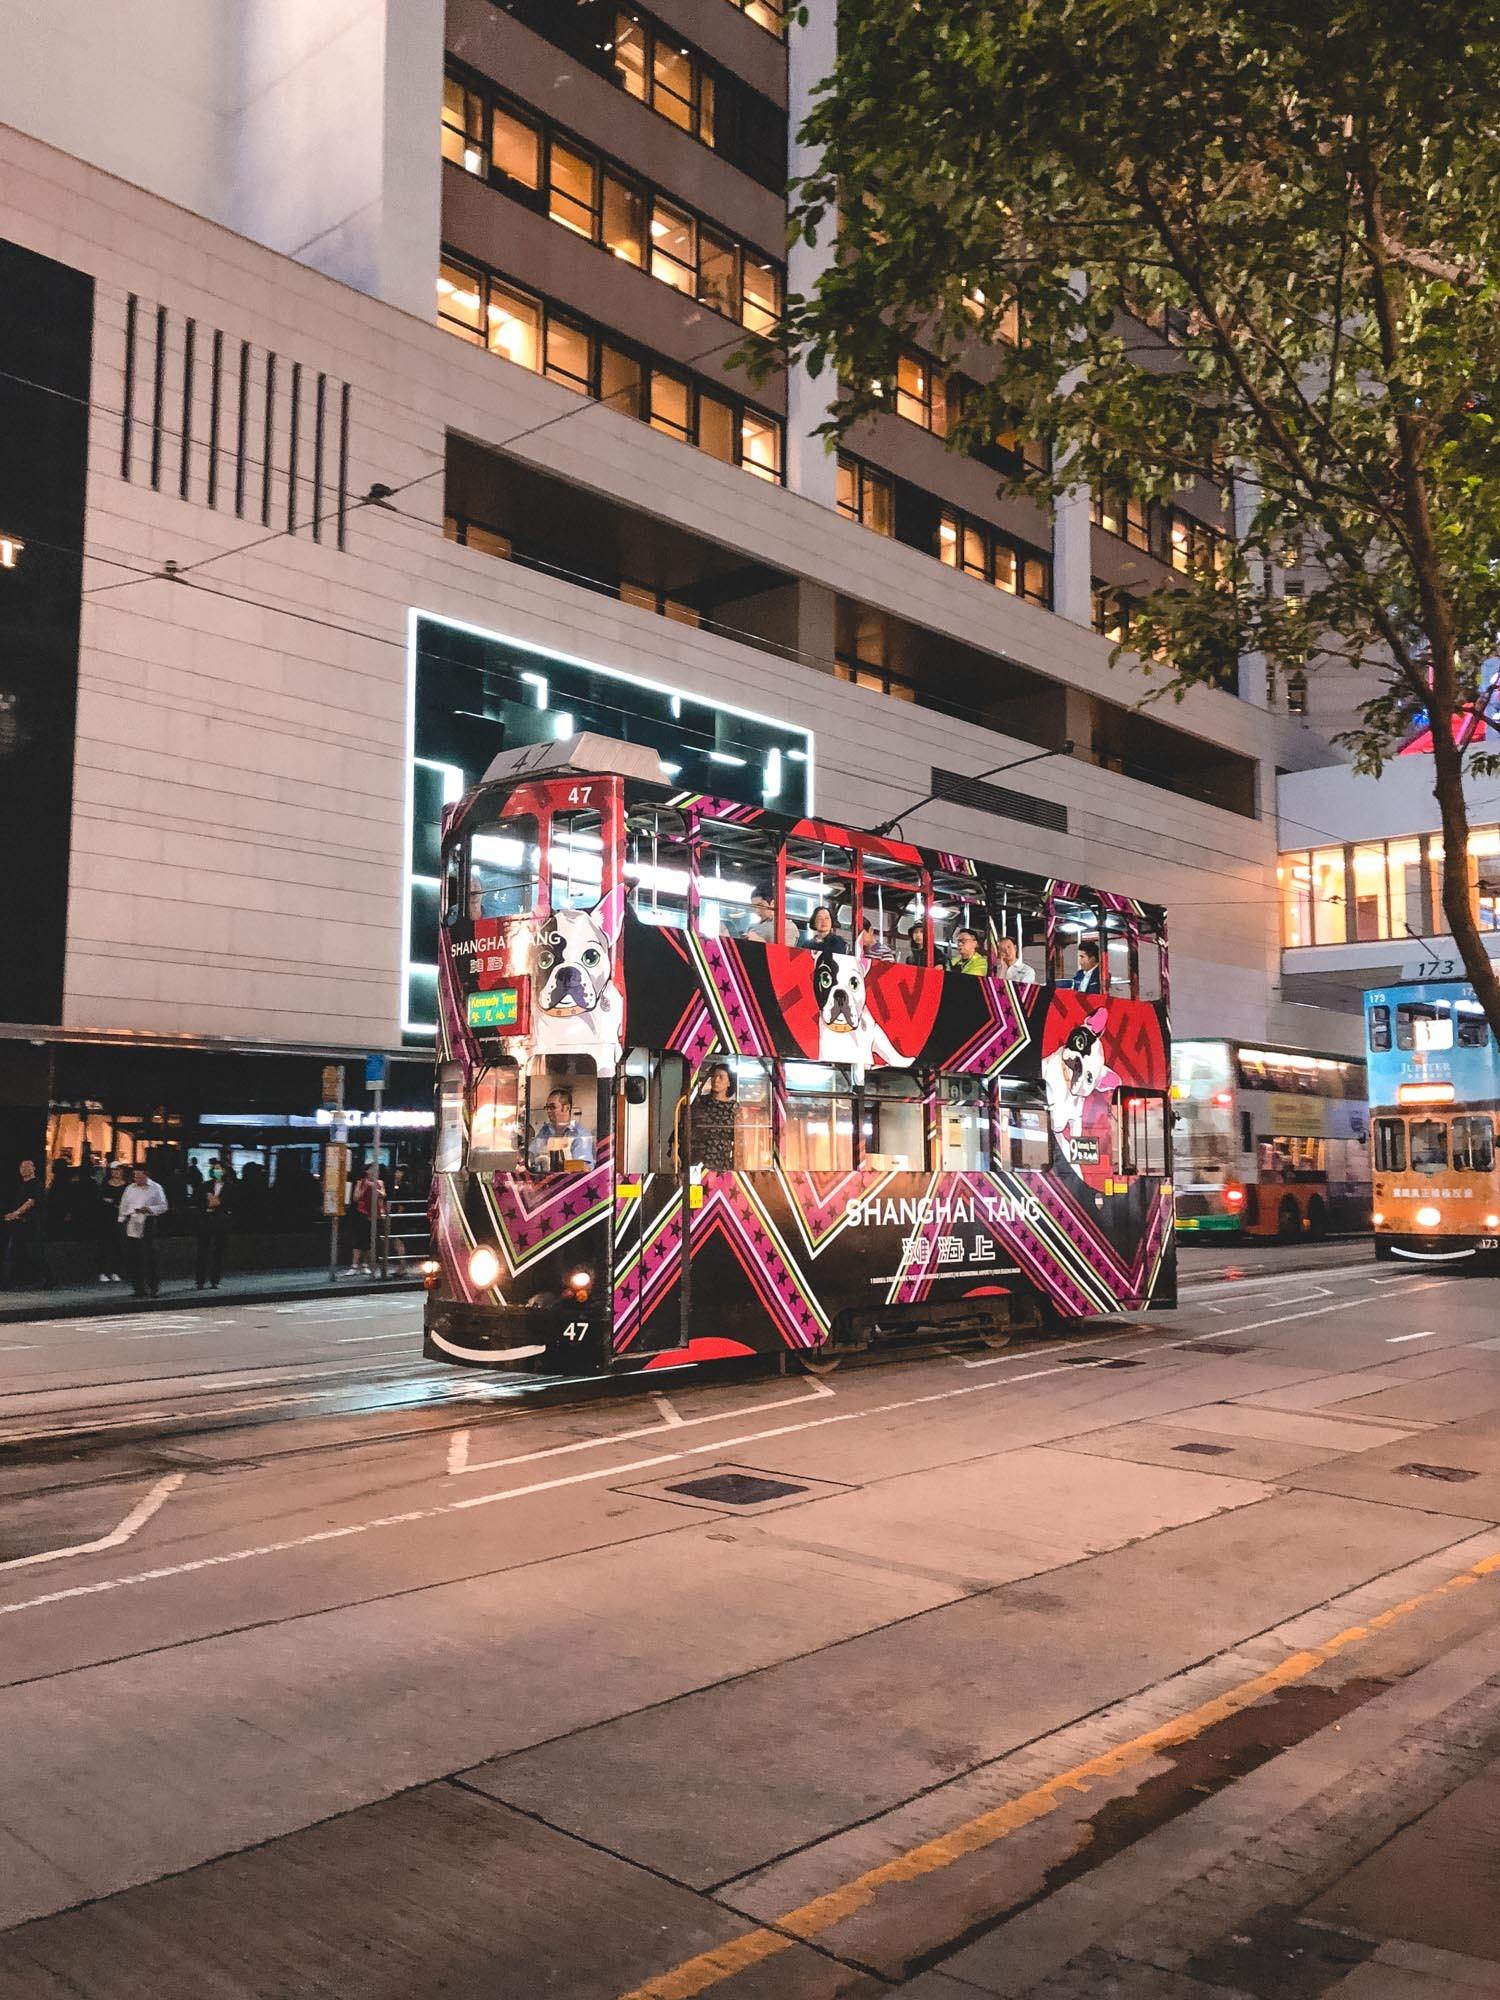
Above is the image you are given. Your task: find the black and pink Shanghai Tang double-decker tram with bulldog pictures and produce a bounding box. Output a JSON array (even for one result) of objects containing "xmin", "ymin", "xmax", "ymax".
[{"xmin": 426, "ymin": 736, "xmax": 1176, "ymax": 1374}]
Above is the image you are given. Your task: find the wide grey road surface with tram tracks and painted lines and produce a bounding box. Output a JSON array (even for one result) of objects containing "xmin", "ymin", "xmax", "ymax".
[{"xmin": 0, "ymin": 1246, "xmax": 1500, "ymax": 2000}]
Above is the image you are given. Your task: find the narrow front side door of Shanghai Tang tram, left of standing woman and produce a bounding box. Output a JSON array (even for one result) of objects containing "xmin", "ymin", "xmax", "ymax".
[{"xmin": 614, "ymin": 1048, "xmax": 692, "ymax": 1356}]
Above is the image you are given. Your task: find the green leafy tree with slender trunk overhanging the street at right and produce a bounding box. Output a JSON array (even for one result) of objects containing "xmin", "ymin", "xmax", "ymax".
[{"xmin": 782, "ymin": 0, "xmax": 1500, "ymax": 1034}]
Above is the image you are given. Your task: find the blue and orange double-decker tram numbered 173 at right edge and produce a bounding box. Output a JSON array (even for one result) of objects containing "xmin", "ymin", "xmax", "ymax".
[{"xmin": 1364, "ymin": 980, "xmax": 1500, "ymax": 1264}]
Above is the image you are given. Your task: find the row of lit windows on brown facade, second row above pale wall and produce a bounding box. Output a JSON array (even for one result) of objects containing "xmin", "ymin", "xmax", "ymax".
[{"xmin": 442, "ymin": 74, "xmax": 786, "ymax": 334}]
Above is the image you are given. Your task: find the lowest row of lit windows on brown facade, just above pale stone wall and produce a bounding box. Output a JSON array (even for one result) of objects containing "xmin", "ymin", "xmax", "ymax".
[{"xmin": 438, "ymin": 256, "xmax": 782, "ymax": 486}]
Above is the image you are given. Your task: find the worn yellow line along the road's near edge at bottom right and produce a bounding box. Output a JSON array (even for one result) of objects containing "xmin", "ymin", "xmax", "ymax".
[{"xmin": 620, "ymin": 1554, "xmax": 1500, "ymax": 2000}]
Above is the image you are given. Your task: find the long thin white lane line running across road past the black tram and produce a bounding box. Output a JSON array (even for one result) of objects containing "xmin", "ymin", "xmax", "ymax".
[{"xmin": 0, "ymin": 1278, "xmax": 1448, "ymax": 1618}]
